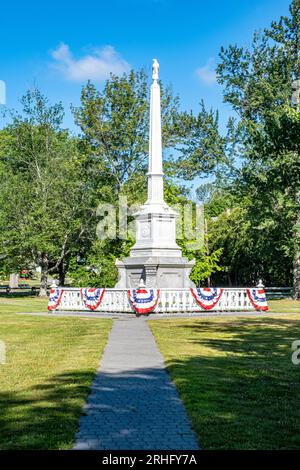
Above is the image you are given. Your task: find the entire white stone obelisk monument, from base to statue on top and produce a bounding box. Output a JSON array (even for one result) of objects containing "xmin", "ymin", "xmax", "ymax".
[{"xmin": 116, "ymin": 59, "xmax": 194, "ymax": 288}]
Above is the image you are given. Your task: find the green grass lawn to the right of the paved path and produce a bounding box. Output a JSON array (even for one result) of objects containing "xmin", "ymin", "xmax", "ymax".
[{"xmin": 150, "ymin": 312, "xmax": 300, "ymax": 449}]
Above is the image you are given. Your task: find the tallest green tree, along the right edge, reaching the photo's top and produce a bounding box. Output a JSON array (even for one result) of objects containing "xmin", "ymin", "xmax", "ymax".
[{"xmin": 217, "ymin": 0, "xmax": 300, "ymax": 298}]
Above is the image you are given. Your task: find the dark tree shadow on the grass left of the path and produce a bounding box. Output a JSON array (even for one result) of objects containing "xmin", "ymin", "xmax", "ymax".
[{"xmin": 0, "ymin": 371, "xmax": 95, "ymax": 450}]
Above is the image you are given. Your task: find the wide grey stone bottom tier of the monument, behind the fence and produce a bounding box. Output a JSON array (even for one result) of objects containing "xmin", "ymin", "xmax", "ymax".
[{"xmin": 115, "ymin": 256, "xmax": 195, "ymax": 289}]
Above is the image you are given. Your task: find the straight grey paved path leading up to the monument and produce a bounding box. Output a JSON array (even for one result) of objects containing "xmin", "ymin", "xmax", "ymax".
[{"xmin": 74, "ymin": 318, "xmax": 198, "ymax": 450}]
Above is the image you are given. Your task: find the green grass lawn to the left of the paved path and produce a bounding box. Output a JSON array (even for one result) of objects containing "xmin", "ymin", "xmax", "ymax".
[{"xmin": 0, "ymin": 298, "xmax": 111, "ymax": 449}]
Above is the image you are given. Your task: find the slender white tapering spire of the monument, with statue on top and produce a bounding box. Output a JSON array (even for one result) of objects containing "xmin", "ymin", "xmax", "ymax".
[{"xmin": 146, "ymin": 59, "xmax": 165, "ymax": 205}]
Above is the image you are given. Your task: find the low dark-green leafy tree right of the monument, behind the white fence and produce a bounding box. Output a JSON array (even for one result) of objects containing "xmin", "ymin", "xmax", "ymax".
[{"xmin": 205, "ymin": 185, "xmax": 293, "ymax": 286}]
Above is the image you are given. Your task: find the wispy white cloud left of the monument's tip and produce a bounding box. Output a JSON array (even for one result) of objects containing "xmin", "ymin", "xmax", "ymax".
[{"xmin": 51, "ymin": 43, "xmax": 130, "ymax": 82}]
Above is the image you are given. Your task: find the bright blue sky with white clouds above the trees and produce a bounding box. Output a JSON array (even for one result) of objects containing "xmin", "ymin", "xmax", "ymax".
[{"xmin": 0, "ymin": 0, "xmax": 290, "ymax": 134}]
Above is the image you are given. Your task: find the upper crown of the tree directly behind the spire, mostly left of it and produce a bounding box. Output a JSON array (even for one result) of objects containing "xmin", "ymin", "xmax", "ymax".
[{"xmin": 74, "ymin": 70, "xmax": 179, "ymax": 193}]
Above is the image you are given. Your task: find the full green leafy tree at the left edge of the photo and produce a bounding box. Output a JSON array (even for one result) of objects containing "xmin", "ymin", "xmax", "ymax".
[{"xmin": 0, "ymin": 89, "xmax": 95, "ymax": 295}]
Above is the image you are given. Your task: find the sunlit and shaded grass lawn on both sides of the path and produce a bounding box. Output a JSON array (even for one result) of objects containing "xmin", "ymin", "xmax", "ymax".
[{"xmin": 0, "ymin": 297, "xmax": 300, "ymax": 449}]
